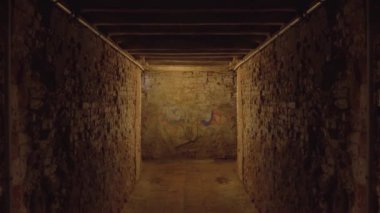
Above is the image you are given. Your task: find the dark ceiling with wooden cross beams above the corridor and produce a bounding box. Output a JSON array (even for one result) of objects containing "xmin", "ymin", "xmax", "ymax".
[{"xmin": 64, "ymin": 0, "xmax": 315, "ymax": 66}]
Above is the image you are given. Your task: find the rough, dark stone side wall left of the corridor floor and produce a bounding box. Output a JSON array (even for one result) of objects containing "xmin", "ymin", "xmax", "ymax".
[{"xmin": 11, "ymin": 0, "xmax": 141, "ymax": 213}]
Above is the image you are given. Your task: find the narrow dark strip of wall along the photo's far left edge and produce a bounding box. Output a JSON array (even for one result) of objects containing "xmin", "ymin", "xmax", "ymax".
[{"xmin": 0, "ymin": 1, "xmax": 8, "ymax": 212}]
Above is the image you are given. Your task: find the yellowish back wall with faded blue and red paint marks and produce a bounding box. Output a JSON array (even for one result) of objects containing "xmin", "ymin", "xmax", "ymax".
[{"xmin": 142, "ymin": 71, "xmax": 236, "ymax": 158}]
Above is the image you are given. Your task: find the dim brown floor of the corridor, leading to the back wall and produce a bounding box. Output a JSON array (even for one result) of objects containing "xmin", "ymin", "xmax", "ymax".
[{"xmin": 123, "ymin": 160, "xmax": 256, "ymax": 213}]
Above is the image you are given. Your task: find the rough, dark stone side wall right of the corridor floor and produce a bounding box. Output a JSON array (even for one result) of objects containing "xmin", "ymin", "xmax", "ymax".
[{"xmin": 237, "ymin": 0, "xmax": 368, "ymax": 213}]
